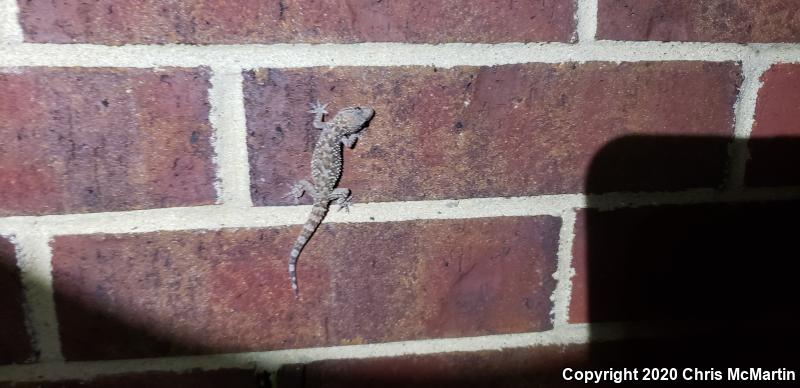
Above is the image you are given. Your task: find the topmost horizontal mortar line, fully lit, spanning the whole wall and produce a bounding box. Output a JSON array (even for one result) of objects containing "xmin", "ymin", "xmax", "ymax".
[{"xmin": 0, "ymin": 40, "xmax": 800, "ymax": 71}]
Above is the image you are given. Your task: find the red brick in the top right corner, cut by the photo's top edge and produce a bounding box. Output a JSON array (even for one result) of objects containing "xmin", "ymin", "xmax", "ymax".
[{"xmin": 597, "ymin": 0, "xmax": 800, "ymax": 43}]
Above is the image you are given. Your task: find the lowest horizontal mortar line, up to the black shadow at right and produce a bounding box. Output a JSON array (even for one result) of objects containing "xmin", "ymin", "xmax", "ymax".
[{"xmin": 0, "ymin": 324, "xmax": 592, "ymax": 382}]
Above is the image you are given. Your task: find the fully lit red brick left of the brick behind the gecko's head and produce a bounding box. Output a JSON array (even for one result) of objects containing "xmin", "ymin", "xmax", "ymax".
[{"xmin": 0, "ymin": 68, "xmax": 215, "ymax": 215}]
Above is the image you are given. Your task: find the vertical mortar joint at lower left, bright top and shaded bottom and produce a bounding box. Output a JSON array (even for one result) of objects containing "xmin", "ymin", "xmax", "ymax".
[{"xmin": 9, "ymin": 228, "xmax": 64, "ymax": 362}]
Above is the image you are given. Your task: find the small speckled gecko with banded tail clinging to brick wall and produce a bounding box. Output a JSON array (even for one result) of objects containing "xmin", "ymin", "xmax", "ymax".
[{"xmin": 284, "ymin": 101, "xmax": 375, "ymax": 298}]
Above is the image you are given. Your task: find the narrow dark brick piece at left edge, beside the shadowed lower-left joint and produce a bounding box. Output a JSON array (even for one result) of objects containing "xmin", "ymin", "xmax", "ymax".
[{"xmin": 0, "ymin": 237, "xmax": 35, "ymax": 364}]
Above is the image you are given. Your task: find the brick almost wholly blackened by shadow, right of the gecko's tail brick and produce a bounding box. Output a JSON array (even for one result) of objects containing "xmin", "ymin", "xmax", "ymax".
[{"xmin": 570, "ymin": 201, "xmax": 800, "ymax": 324}]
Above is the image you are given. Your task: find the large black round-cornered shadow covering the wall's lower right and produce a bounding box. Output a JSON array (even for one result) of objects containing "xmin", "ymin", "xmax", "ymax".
[{"xmin": 571, "ymin": 136, "xmax": 800, "ymax": 386}]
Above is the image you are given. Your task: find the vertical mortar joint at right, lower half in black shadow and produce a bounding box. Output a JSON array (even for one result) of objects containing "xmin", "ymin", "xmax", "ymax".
[{"xmin": 725, "ymin": 56, "xmax": 772, "ymax": 190}]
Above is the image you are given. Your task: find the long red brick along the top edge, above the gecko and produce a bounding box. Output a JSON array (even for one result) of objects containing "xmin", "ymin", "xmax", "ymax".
[{"xmin": 20, "ymin": 0, "xmax": 575, "ymax": 45}]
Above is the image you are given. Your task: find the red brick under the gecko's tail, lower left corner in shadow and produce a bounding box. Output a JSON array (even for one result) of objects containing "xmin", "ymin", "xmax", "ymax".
[{"xmin": 53, "ymin": 217, "xmax": 560, "ymax": 360}]
